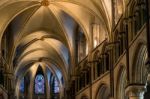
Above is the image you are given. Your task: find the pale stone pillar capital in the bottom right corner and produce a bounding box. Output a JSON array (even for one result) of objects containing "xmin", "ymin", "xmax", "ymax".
[{"xmin": 125, "ymin": 84, "xmax": 146, "ymax": 99}]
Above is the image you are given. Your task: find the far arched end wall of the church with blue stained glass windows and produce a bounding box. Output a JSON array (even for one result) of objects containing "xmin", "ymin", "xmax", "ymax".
[{"xmin": 16, "ymin": 63, "xmax": 64, "ymax": 99}]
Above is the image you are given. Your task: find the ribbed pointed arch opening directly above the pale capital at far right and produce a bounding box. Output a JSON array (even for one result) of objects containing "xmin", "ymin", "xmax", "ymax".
[{"xmin": 130, "ymin": 42, "xmax": 147, "ymax": 84}]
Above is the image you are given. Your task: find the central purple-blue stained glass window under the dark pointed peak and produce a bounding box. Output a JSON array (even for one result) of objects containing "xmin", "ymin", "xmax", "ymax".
[{"xmin": 35, "ymin": 74, "xmax": 45, "ymax": 94}]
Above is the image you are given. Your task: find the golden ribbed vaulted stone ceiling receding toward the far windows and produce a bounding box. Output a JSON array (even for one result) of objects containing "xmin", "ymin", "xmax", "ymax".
[{"xmin": 0, "ymin": 0, "xmax": 112, "ymax": 85}]
